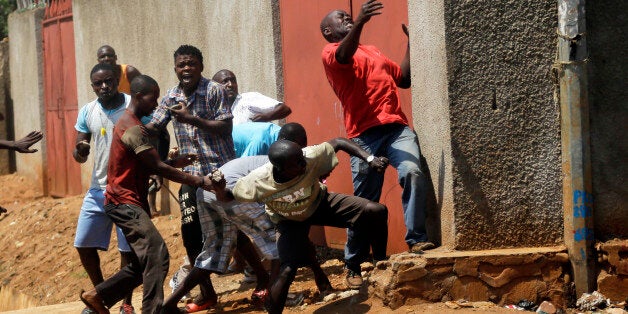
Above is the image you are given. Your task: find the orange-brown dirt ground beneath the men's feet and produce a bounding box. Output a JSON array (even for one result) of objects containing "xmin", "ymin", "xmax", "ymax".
[{"xmin": 0, "ymin": 174, "xmax": 528, "ymax": 313}]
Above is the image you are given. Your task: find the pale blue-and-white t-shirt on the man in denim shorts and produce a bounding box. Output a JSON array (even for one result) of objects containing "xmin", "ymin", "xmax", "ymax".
[{"xmin": 74, "ymin": 94, "xmax": 131, "ymax": 190}]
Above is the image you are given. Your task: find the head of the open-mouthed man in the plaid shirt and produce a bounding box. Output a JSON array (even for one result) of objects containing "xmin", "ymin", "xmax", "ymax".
[{"xmin": 174, "ymin": 45, "xmax": 203, "ymax": 93}]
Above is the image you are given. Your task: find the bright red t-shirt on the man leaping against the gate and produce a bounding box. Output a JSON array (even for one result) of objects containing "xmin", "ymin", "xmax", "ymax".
[{"xmin": 322, "ymin": 43, "xmax": 408, "ymax": 138}]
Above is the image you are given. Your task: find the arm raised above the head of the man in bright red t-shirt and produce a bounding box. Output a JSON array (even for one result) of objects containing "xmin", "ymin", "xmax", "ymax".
[{"xmin": 336, "ymin": 0, "xmax": 384, "ymax": 64}]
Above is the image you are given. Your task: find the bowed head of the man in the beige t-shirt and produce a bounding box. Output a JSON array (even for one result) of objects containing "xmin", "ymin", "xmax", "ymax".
[{"xmin": 268, "ymin": 140, "xmax": 307, "ymax": 180}]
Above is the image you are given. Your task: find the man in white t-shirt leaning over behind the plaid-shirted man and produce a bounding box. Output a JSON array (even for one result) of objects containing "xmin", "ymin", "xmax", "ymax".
[{"xmin": 212, "ymin": 70, "xmax": 292, "ymax": 128}]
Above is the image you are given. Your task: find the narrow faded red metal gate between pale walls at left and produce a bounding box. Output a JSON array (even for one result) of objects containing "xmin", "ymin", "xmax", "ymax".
[{"xmin": 42, "ymin": 0, "xmax": 82, "ymax": 197}]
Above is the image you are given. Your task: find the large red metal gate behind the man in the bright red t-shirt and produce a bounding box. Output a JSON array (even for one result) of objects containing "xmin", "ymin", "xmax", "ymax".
[{"xmin": 280, "ymin": 0, "xmax": 412, "ymax": 254}]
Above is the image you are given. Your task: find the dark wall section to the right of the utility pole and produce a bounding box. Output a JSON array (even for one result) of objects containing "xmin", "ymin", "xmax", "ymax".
[{"xmin": 586, "ymin": 1, "xmax": 628, "ymax": 240}]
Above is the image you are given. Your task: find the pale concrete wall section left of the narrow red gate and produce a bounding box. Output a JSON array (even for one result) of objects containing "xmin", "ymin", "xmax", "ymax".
[{"xmin": 9, "ymin": 9, "xmax": 46, "ymax": 190}]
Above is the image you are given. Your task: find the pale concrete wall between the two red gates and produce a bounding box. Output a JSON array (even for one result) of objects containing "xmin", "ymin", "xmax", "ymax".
[{"xmin": 72, "ymin": 0, "xmax": 283, "ymax": 189}]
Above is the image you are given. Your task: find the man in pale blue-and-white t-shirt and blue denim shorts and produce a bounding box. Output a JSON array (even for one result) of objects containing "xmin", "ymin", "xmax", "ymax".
[{"xmin": 72, "ymin": 63, "xmax": 133, "ymax": 314}]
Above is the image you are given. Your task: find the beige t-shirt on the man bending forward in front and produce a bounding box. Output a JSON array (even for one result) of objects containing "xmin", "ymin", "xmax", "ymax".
[{"xmin": 232, "ymin": 143, "xmax": 338, "ymax": 223}]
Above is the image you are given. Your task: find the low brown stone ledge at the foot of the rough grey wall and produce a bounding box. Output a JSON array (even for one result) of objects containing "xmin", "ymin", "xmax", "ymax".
[{"xmin": 369, "ymin": 247, "xmax": 569, "ymax": 309}]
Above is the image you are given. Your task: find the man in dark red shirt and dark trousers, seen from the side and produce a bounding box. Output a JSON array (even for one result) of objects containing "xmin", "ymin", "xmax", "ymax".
[{"xmin": 80, "ymin": 75, "xmax": 211, "ymax": 313}]
